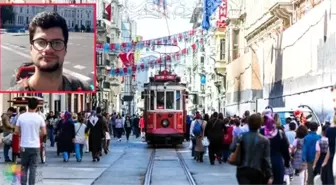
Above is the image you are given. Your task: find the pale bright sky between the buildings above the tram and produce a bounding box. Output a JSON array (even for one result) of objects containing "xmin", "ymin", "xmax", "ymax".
[{"xmin": 123, "ymin": 0, "xmax": 198, "ymax": 89}]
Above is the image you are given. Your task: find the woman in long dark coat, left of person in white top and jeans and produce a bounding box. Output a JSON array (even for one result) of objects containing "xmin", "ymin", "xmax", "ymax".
[{"xmin": 57, "ymin": 111, "xmax": 76, "ymax": 162}]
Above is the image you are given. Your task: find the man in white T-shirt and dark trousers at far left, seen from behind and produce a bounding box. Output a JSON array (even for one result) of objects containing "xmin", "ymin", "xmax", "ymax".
[{"xmin": 15, "ymin": 98, "xmax": 47, "ymax": 185}]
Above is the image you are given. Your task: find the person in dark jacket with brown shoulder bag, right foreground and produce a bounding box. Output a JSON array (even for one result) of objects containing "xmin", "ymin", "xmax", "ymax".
[{"xmin": 232, "ymin": 114, "xmax": 273, "ymax": 185}]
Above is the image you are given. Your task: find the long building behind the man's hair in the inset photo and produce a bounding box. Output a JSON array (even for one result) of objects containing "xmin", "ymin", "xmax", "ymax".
[{"xmin": 4, "ymin": 5, "xmax": 95, "ymax": 30}]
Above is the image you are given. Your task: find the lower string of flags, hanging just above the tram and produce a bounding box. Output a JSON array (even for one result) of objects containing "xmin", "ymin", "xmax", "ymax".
[{"xmin": 110, "ymin": 42, "xmax": 203, "ymax": 77}]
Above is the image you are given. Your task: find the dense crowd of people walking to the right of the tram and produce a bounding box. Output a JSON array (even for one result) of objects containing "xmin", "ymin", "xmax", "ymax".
[{"xmin": 187, "ymin": 110, "xmax": 336, "ymax": 185}]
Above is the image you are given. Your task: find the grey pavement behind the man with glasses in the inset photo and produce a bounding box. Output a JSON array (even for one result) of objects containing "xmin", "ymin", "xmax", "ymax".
[{"xmin": 0, "ymin": 32, "xmax": 95, "ymax": 90}]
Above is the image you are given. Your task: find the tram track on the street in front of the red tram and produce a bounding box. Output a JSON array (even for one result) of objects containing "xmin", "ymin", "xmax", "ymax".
[{"xmin": 143, "ymin": 148, "xmax": 197, "ymax": 185}]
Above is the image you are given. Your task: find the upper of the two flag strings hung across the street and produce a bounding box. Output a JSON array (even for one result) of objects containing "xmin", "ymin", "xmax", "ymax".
[{"xmin": 96, "ymin": 29, "xmax": 204, "ymax": 53}]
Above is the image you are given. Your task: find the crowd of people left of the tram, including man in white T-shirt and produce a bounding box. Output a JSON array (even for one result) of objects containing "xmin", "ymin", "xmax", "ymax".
[{"xmin": 0, "ymin": 98, "xmax": 144, "ymax": 184}]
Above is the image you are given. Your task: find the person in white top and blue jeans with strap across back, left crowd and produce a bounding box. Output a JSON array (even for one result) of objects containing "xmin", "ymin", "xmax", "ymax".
[{"xmin": 74, "ymin": 113, "xmax": 86, "ymax": 162}]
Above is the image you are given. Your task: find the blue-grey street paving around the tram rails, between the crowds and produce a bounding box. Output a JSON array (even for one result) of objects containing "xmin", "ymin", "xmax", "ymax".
[{"xmin": 0, "ymin": 136, "xmax": 299, "ymax": 185}]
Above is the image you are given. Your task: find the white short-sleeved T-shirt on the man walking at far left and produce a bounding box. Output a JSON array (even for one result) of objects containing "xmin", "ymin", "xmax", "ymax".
[{"xmin": 16, "ymin": 112, "xmax": 45, "ymax": 148}]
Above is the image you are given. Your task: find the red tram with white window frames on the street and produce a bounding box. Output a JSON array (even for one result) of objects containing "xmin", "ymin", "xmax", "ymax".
[{"xmin": 142, "ymin": 70, "xmax": 188, "ymax": 145}]
